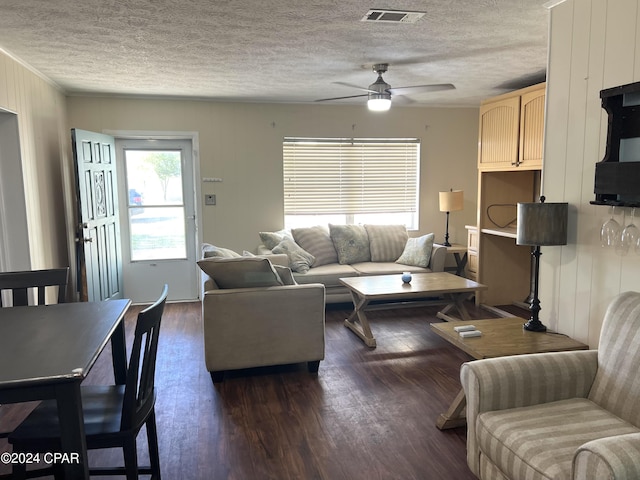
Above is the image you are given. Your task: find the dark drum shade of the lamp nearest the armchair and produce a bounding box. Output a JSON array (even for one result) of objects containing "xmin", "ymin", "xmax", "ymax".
[{"xmin": 516, "ymin": 203, "xmax": 569, "ymax": 246}]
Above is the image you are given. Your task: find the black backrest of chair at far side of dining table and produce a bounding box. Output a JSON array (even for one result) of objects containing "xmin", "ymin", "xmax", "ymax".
[{"xmin": 0, "ymin": 267, "xmax": 69, "ymax": 307}]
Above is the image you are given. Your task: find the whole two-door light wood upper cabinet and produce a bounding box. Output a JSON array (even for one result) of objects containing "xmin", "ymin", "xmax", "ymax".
[{"xmin": 478, "ymin": 83, "xmax": 546, "ymax": 171}]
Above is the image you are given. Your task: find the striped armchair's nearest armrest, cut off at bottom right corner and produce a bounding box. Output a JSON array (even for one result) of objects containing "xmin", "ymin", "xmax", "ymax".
[{"xmin": 572, "ymin": 433, "xmax": 640, "ymax": 480}]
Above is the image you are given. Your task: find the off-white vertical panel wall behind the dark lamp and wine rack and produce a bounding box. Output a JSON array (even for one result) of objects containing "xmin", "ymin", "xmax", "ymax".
[{"xmin": 541, "ymin": 0, "xmax": 640, "ymax": 347}]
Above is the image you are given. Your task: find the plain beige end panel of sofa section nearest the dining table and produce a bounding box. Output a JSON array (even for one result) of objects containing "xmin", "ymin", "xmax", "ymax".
[{"xmin": 202, "ymin": 284, "xmax": 325, "ymax": 372}]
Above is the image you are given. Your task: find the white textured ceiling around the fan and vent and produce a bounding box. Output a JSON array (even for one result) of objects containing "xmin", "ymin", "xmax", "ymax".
[{"xmin": 0, "ymin": 0, "xmax": 548, "ymax": 106}]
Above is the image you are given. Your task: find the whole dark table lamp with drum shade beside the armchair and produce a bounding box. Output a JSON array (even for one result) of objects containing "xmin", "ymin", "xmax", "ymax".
[{"xmin": 516, "ymin": 197, "xmax": 569, "ymax": 332}]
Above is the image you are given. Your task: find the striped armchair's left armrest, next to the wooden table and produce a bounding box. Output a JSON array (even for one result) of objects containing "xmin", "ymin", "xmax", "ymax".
[{"xmin": 460, "ymin": 350, "xmax": 598, "ymax": 474}]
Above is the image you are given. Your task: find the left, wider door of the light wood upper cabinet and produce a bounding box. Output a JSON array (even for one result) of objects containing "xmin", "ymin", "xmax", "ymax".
[{"xmin": 478, "ymin": 96, "xmax": 520, "ymax": 170}]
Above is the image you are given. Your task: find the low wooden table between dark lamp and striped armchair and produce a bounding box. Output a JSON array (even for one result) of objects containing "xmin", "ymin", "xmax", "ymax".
[{"xmin": 431, "ymin": 317, "xmax": 589, "ymax": 430}]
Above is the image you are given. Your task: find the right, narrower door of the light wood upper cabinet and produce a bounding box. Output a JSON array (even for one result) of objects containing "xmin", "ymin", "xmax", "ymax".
[{"xmin": 519, "ymin": 87, "xmax": 545, "ymax": 169}]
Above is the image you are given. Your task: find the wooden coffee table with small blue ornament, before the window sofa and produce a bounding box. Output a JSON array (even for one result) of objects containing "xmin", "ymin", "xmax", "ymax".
[{"xmin": 340, "ymin": 272, "xmax": 487, "ymax": 348}]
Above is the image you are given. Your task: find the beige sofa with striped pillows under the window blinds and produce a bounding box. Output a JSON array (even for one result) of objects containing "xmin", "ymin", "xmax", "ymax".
[{"xmin": 257, "ymin": 225, "xmax": 447, "ymax": 303}]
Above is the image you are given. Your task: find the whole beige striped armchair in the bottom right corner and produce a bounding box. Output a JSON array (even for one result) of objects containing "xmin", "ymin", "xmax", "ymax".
[{"xmin": 460, "ymin": 292, "xmax": 640, "ymax": 480}]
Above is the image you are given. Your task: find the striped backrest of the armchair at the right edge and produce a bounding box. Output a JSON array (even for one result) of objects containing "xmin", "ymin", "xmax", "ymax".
[{"xmin": 589, "ymin": 292, "xmax": 640, "ymax": 427}]
